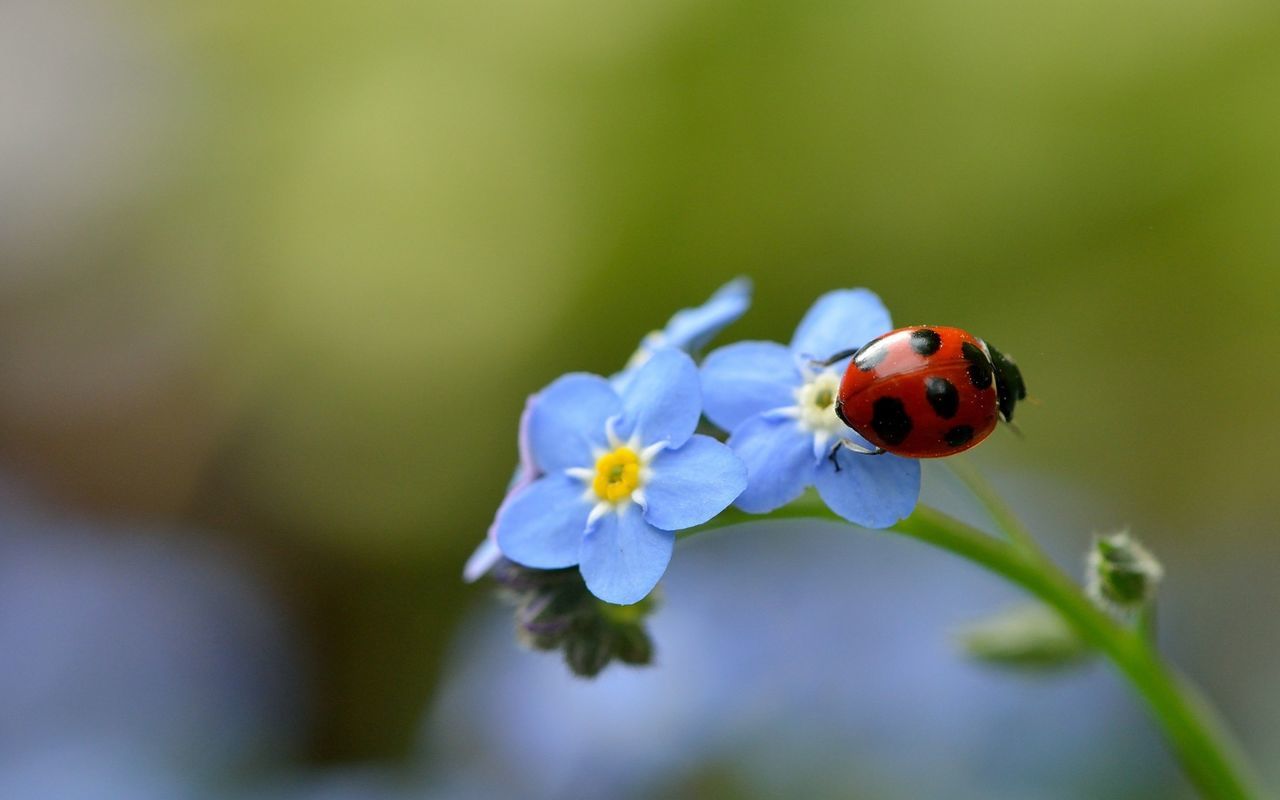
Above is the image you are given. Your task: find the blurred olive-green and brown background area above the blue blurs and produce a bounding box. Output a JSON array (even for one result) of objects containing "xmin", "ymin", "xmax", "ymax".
[{"xmin": 0, "ymin": 0, "xmax": 1280, "ymax": 778}]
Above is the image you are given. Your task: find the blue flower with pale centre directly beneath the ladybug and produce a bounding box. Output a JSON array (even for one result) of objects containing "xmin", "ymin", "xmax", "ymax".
[{"xmin": 701, "ymin": 289, "xmax": 920, "ymax": 527}]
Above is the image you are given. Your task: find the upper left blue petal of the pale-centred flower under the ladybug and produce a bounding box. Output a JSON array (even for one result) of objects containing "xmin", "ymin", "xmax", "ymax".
[{"xmin": 701, "ymin": 342, "xmax": 803, "ymax": 430}]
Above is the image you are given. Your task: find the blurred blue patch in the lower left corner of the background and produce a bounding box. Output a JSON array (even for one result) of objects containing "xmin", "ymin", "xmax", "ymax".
[{"xmin": 0, "ymin": 483, "xmax": 306, "ymax": 800}]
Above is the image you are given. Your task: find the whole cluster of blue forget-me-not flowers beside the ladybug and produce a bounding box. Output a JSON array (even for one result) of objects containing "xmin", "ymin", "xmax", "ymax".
[{"xmin": 465, "ymin": 279, "xmax": 920, "ymax": 672}]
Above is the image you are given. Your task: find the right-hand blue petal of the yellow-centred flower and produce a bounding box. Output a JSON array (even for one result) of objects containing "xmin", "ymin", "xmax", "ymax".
[{"xmin": 644, "ymin": 435, "xmax": 746, "ymax": 530}]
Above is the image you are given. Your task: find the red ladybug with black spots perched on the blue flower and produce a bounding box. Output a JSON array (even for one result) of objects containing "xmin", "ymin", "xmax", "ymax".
[{"xmin": 823, "ymin": 325, "xmax": 1027, "ymax": 458}]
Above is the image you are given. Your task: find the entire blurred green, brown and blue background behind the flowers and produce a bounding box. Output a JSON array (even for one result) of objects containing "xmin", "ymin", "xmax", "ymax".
[{"xmin": 0, "ymin": 0, "xmax": 1280, "ymax": 800}]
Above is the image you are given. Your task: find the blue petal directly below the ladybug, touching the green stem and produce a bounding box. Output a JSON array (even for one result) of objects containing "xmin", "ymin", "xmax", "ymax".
[{"xmin": 815, "ymin": 448, "xmax": 920, "ymax": 527}]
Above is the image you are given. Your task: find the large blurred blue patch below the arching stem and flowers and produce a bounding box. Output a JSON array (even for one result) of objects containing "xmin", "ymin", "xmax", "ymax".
[{"xmin": 424, "ymin": 504, "xmax": 1178, "ymax": 800}]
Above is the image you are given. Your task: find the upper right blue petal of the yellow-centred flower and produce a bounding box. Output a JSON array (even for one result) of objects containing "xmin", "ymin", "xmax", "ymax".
[{"xmin": 617, "ymin": 349, "xmax": 703, "ymax": 448}]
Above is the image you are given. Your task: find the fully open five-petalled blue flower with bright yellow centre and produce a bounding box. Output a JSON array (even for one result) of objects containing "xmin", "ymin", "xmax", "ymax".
[{"xmin": 497, "ymin": 348, "xmax": 746, "ymax": 604}]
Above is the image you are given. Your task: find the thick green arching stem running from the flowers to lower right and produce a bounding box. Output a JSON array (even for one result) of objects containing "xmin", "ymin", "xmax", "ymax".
[{"xmin": 686, "ymin": 499, "xmax": 1258, "ymax": 800}]
